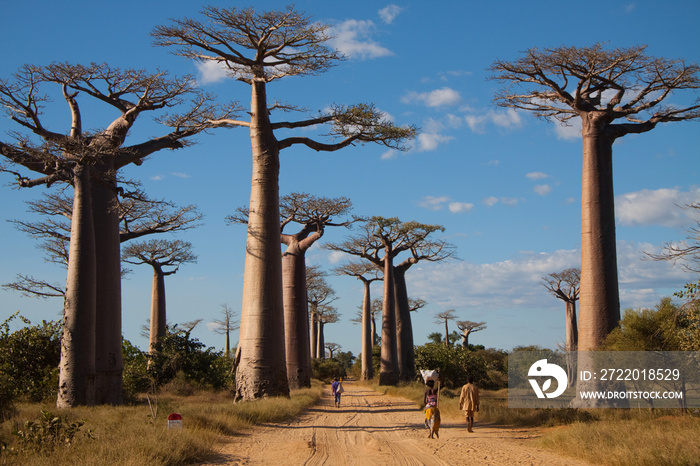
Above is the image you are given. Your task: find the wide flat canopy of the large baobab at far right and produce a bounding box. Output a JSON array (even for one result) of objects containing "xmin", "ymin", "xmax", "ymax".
[{"xmin": 490, "ymin": 43, "xmax": 700, "ymax": 133}]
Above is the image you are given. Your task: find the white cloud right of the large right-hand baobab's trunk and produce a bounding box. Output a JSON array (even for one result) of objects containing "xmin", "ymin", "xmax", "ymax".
[{"xmin": 615, "ymin": 188, "xmax": 700, "ymax": 227}]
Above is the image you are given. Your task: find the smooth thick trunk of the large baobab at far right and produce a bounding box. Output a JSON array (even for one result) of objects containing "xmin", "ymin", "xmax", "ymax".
[{"xmin": 578, "ymin": 122, "xmax": 620, "ymax": 351}]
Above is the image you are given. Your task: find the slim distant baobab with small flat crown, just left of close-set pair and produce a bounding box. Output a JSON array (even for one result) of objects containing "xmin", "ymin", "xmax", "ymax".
[{"xmin": 335, "ymin": 262, "xmax": 382, "ymax": 380}]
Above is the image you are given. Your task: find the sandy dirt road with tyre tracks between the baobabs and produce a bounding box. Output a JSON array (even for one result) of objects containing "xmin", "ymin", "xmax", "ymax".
[{"xmin": 202, "ymin": 382, "xmax": 588, "ymax": 466}]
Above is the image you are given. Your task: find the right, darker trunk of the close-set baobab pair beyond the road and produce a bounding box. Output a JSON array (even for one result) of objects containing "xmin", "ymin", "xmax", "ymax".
[{"xmin": 394, "ymin": 267, "xmax": 416, "ymax": 382}]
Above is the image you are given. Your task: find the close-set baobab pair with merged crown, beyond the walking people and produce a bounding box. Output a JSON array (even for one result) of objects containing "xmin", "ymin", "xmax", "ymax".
[{"xmin": 326, "ymin": 217, "xmax": 452, "ymax": 385}]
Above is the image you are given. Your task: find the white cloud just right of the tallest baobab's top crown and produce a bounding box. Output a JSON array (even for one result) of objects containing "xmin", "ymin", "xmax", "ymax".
[{"xmin": 329, "ymin": 19, "xmax": 393, "ymax": 60}]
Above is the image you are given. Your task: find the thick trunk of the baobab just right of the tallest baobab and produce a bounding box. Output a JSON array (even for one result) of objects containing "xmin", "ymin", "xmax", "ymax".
[{"xmin": 282, "ymin": 248, "xmax": 311, "ymax": 389}]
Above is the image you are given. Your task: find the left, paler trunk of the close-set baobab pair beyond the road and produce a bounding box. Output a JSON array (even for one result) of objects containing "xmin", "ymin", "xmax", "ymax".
[{"xmin": 379, "ymin": 246, "xmax": 399, "ymax": 385}]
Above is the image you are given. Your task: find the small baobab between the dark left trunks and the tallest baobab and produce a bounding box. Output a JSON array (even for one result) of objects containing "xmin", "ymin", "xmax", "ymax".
[{"xmin": 122, "ymin": 239, "xmax": 197, "ymax": 353}]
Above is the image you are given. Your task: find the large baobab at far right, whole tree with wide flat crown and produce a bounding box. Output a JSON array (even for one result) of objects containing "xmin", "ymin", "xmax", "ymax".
[{"xmin": 490, "ymin": 43, "xmax": 700, "ymax": 351}]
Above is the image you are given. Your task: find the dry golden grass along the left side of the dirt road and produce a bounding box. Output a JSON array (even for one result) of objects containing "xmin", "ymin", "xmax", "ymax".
[{"xmin": 0, "ymin": 382, "xmax": 323, "ymax": 466}]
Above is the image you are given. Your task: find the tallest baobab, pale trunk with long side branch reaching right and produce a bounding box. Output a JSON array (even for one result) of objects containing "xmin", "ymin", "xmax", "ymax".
[{"xmin": 153, "ymin": 6, "xmax": 416, "ymax": 400}]
